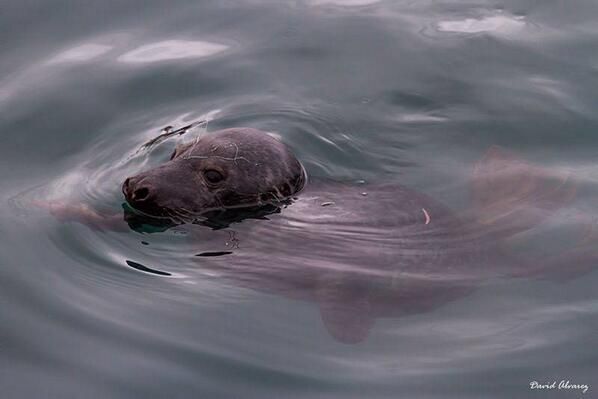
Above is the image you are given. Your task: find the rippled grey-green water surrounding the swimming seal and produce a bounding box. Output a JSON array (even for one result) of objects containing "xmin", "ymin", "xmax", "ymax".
[{"xmin": 0, "ymin": 0, "xmax": 598, "ymax": 398}]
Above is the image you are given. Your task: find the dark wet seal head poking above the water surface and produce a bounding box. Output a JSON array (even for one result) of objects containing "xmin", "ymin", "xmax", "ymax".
[{"xmin": 122, "ymin": 128, "xmax": 307, "ymax": 221}]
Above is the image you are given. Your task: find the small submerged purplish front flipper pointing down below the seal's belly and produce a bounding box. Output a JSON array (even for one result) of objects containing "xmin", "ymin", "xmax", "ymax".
[{"xmin": 316, "ymin": 276, "xmax": 374, "ymax": 344}]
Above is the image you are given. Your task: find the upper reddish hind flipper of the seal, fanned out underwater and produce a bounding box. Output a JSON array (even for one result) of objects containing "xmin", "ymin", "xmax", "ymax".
[{"xmin": 471, "ymin": 146, "xmax": 577, "ymax": 238}]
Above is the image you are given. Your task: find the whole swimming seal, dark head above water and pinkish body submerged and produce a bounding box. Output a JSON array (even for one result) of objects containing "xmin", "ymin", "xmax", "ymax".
[{"xmin": 117, "ymin": 128, "xmax": 584, "ymax": 342}]
